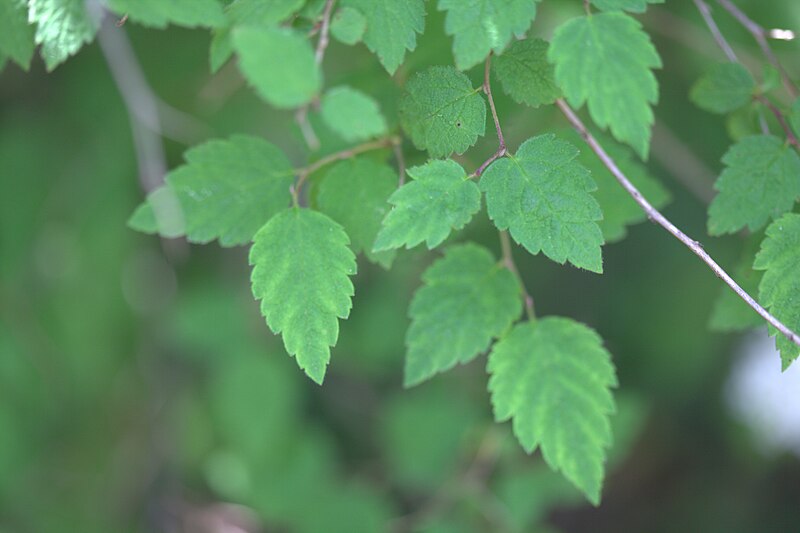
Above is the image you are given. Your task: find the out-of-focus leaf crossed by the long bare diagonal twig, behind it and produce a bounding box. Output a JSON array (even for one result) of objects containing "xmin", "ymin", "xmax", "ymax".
[{"xmin": 564, "ymin": 130, "xmax": 670, "ymax": 243}]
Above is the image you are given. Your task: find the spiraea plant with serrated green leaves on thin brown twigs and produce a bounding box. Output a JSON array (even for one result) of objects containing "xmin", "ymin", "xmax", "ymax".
[{"xmin": 6, "ymin": 0, "xmax": 800, "ymax": 505}]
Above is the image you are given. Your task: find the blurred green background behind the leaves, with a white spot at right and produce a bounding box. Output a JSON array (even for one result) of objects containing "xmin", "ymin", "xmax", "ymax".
[{"xmin": 0, "ymin": 0, "xmax": 800, "ymax": 533}]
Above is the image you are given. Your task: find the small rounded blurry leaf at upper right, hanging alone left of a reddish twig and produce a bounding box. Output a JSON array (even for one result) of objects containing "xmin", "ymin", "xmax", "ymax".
[{"xmin": 689, "ymin": 63, "xmax": 756, "ymax": 114}]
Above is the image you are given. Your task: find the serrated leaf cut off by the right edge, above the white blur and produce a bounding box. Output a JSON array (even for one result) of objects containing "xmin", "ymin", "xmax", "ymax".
[{"xmin": 753, "ymin": 213, "xmax": 800, "ymax": 370}]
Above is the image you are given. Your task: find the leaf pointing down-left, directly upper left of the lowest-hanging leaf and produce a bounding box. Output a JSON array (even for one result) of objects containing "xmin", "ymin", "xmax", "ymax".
[{"xmin": 404, "ymin": 244, "xmax": 522, "ymax": 387}]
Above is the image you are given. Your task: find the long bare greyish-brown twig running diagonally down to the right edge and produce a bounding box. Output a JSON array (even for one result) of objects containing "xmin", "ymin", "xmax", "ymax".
[{"xmin": 556, "ymin": 99, "xmax": 800, "ymax": 346}]
